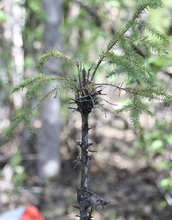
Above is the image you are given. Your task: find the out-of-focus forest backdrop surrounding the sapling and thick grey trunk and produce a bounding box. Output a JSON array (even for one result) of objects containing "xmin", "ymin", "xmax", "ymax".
[{"xmin": 0, "ymin": 0, "xmax": 172, "ymax": 220}]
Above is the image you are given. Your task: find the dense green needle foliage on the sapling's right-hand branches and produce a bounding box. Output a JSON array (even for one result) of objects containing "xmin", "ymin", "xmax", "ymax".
[{"xmin": 99, "ymin": 0, "xmax": 172, "ymax": 129}]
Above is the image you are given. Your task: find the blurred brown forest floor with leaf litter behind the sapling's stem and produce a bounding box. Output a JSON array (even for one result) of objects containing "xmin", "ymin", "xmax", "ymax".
[{"xmin": 0, "ymin": 98, "xmax": 172, "ymax": 220}]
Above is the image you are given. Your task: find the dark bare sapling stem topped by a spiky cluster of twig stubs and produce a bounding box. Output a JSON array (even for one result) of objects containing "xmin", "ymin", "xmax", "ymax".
[{"xmin": 70, "ymin": 56, "xmax": 110, "ymax": 220}]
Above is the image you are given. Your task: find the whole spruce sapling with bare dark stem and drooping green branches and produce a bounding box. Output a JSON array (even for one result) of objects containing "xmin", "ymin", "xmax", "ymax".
[{"xmin": 6, "ymin": 0, "xmax": 172, "ymax": 220}]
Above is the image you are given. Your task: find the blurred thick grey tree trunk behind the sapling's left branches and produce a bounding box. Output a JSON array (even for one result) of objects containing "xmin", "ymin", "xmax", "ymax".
[{"xmin": 37, "ymin": 0, "xmax": 61, "ymax": 178}]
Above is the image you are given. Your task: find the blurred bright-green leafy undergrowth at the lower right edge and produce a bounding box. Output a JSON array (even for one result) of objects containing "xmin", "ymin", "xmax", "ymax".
[{"xmin": 134, "ymin": 121, "xmax": 172, "ymax": 206}]
